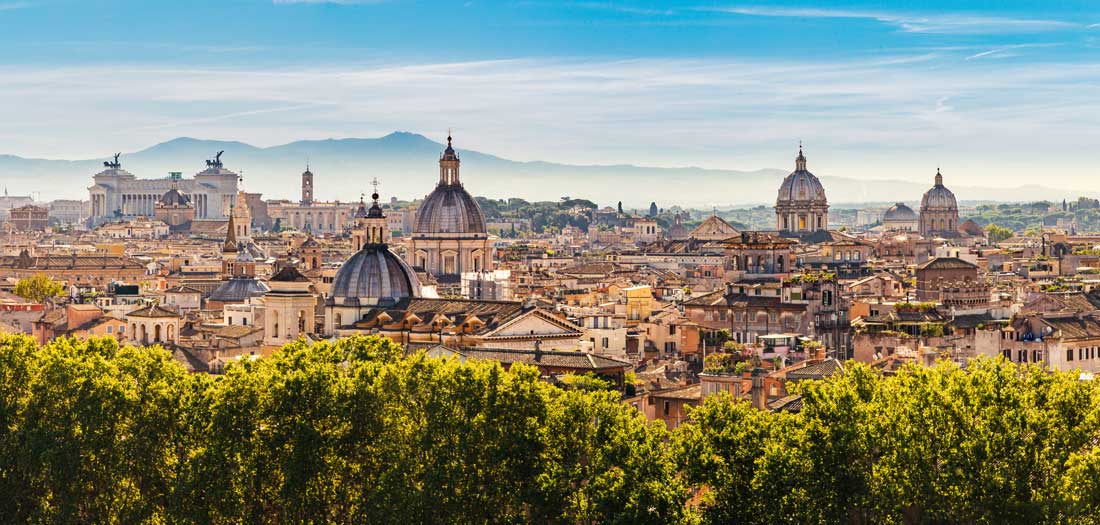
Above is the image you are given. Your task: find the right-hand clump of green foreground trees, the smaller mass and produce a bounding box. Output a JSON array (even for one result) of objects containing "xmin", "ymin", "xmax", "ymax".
[{"xmin": 674, "ymin": 359, "xmax": 1100, "ymax": 523}]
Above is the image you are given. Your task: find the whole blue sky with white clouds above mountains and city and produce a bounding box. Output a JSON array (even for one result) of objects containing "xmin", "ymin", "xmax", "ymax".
[{"xmin": 0, "ymin": 0, "xmax": 1100, "ymax": 190}]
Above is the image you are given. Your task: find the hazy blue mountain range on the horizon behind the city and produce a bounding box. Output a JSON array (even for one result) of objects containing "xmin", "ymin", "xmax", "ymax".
[{"xmin": 0, "ymin": 132, "xmax": 1084, "ymax": 208}]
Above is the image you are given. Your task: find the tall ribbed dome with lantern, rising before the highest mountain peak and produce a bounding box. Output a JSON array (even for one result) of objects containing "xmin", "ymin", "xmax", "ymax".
[{"xmin": 413, "ymin": 136, "xmax": 487, "ymax": 234}]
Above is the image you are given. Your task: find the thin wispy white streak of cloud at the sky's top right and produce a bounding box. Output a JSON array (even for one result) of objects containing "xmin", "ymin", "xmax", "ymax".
[{"xmin": 714, "ymin": 7, "xmax": 1080, "ymax": 34}]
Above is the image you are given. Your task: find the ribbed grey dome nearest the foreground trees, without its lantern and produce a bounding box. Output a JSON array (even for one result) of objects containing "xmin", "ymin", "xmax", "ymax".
[{"xmin": 329, "ymin": 244, "xmax": 420, "ymax": 306}]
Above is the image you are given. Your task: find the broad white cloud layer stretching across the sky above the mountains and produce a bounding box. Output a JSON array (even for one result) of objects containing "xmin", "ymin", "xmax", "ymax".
[{"xmin": 0, "ymin": 54, "xmax": 1100, "ymax": 193}]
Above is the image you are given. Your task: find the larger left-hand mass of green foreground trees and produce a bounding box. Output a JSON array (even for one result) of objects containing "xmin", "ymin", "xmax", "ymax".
[{"xmin": 0, "ymin": 336, "xmax": 688, "ymax": 524}]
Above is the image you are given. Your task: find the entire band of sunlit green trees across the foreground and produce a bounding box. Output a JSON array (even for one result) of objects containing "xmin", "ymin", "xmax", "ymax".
[{"xmin": 0, "ymin": 336, "xmax": 1100, "ymax": 524}]
